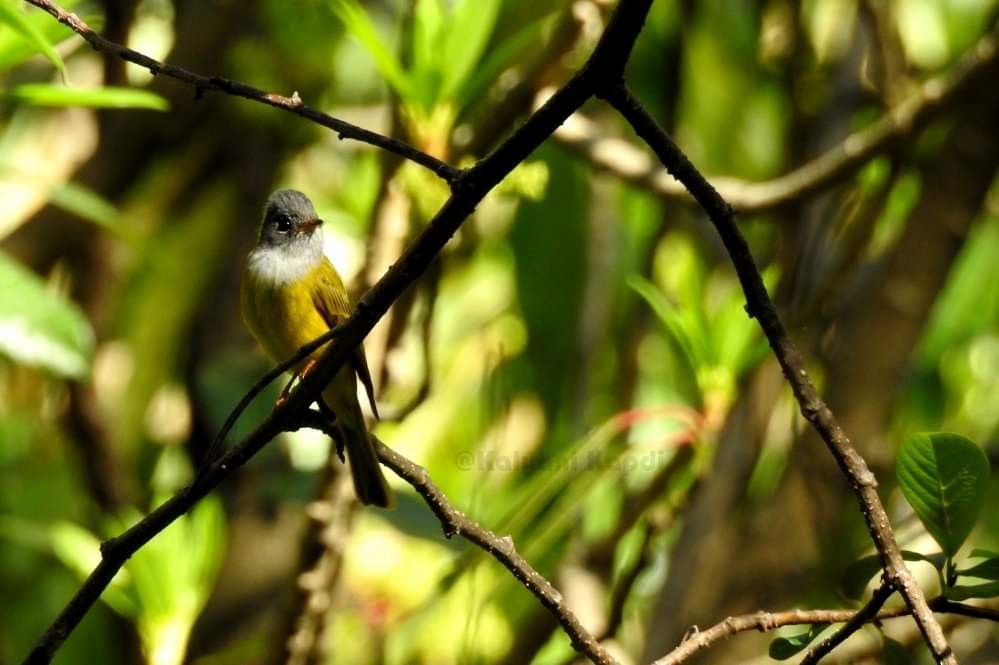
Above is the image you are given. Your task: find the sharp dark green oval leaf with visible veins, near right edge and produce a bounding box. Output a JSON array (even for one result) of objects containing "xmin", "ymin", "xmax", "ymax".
[{"xmin": 895, "ymin": 432, "xmax": 989, "ymax": 557}]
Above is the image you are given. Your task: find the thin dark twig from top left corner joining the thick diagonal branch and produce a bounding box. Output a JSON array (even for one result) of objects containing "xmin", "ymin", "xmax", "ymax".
[{"xmin": 25, "ymin": 0, "xmax": 462, "ymax": 185}]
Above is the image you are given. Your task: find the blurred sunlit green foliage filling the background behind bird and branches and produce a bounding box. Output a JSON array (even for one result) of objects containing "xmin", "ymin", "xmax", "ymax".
[{"xmin": 0, "ymin": 0, "xmax": 999, "ymax": 665}]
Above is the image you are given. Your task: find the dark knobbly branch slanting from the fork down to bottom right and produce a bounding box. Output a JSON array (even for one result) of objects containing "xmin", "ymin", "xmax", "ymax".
[{"xmin": 602, "ymin": 81, "xmax": 957, "ymax": 665}]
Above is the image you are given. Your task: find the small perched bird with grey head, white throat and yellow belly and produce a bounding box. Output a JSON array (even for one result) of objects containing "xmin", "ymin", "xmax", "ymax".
[{"xmin": 240, "ymin": 189, "xmax": 393, "ymax": 508}]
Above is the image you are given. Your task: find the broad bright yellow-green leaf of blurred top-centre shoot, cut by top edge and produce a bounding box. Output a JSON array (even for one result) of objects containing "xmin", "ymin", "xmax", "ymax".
[{"xmin": 441, "ymin": 0, "xmax": 500, "ymax": 100}]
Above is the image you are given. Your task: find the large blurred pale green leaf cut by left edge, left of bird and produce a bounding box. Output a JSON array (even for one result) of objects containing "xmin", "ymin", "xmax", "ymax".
[{"xmin": 0, "ymin": 253, "xmax": 94, "ymax": 378}]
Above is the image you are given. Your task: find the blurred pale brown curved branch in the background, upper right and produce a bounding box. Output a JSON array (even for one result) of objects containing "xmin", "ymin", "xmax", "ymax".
[{"xmin": 555, "ymin": 22, "xmax": 999, "ymax": 214}]
